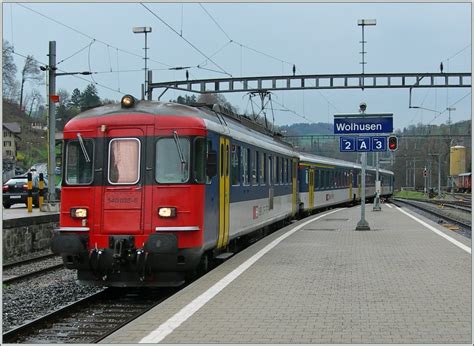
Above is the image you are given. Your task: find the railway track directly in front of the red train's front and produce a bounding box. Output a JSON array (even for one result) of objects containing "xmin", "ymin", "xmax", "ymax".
[{"xmin": 3, "ymin": 288, "xmax": 177, "ymax": 344}]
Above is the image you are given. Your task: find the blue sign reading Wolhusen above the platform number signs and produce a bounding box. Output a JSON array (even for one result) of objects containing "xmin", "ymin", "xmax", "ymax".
[{"xmin": 334, "ymin": 113, "xmax": 393, "ymax": 135}]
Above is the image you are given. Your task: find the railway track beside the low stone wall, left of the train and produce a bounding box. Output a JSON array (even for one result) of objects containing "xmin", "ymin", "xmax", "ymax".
[{"xmin": 2, "ymin": 254, "xmax": 64, "ymax": 285}]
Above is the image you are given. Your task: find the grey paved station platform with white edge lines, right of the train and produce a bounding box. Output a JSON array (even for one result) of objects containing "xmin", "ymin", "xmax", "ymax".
[{"xmin": 102, "ymin": 204, "xmax": 472, "ymax": 344}]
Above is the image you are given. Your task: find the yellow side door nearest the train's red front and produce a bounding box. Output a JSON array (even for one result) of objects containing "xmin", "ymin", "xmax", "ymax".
[{"xmin": 217, "ymin": 137, "xmax": 230, "ymax": 248}]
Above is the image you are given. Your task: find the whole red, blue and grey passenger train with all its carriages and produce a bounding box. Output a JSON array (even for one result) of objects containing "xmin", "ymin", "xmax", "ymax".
[{"xmin": 51, "ymin": 95, "xmax": 393, "ymax": 286}]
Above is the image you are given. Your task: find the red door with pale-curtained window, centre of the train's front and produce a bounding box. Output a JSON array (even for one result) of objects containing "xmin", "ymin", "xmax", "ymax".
[{"xmin": 101, "ymin": 128, "xmax": 146, "ymax": 235}]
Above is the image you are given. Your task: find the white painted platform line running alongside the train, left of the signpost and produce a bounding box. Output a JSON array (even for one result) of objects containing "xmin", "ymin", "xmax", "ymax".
[{"xmin": 139, "ymin": 208, "xmax": 346, "ymax": 344}]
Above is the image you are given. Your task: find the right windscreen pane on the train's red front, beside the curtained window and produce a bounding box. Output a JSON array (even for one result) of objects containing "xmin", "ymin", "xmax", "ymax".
[{"xmin": 155, "ymin": 137, "xmax": 190, "ymax": 184}]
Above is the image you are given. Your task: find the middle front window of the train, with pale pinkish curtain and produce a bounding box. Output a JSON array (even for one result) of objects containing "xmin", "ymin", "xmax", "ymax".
[{"xmin": 108, "ymin": 138, "xmax": 140, "ymax": 185}]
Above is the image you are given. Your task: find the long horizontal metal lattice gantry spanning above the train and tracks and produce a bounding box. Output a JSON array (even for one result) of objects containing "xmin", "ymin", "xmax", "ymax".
[{"xmin": 148, "ymin": 71, "xmax": 471, "ymax": 99}]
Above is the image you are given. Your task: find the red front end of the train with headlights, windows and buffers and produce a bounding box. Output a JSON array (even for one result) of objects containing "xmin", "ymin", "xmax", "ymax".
[{"xmin": 51, "ymin": 99, "xmax": 206, "ymax": 287}]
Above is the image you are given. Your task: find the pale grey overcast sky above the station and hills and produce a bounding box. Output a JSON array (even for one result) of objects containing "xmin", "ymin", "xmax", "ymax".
[{"xmin": 3, "ymin": 3, "xmax": 472, "ymax": 128}]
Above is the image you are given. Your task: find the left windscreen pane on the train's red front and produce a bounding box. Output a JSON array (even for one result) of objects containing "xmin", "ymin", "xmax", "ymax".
[{"xmin": 65, "ymin": 139, "xmax": 94, "ymax": 185}]
